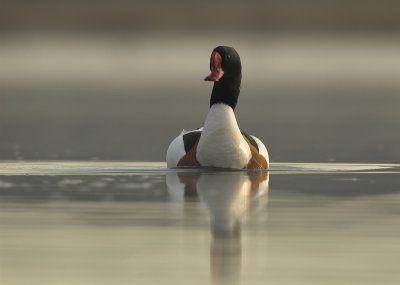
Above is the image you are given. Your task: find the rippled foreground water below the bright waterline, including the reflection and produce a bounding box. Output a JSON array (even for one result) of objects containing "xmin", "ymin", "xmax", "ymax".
[{"xmin": 0, "ymin": 161, "xmax": 400, "ymax": 285}]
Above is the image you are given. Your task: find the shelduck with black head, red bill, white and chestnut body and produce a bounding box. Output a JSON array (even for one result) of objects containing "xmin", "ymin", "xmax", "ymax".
[{"xmin": 166, "ymin": 46, "xmax": 269, "ymax": 170}]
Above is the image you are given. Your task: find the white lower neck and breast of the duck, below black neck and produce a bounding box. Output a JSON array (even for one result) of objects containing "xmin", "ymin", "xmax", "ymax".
[{"xmin": 196, "ymin": 103, "xmax": 251, "ymax": 169}]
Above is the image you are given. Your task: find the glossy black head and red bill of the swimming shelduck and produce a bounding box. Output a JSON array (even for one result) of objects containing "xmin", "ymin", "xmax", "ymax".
[{"xmin": 204, "ymin": 46, "xmax": 242, "ymax": 83}]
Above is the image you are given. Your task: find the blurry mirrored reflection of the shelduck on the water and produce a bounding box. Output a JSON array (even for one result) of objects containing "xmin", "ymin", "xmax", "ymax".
[{"xmin": 167, "ymin": 171, "xmax": 269, "ymax": 284}]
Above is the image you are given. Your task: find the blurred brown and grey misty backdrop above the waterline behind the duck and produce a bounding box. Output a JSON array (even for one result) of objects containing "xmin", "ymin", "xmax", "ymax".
[{"xmin": 0, "ymin": 0, "xmax": 400, "ymax": 163}]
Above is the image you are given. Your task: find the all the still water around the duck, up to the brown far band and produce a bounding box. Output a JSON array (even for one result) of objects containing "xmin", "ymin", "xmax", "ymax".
[{"xmin": 0, "ymin": 30, "xmax": 400, "ymax": 285}]
